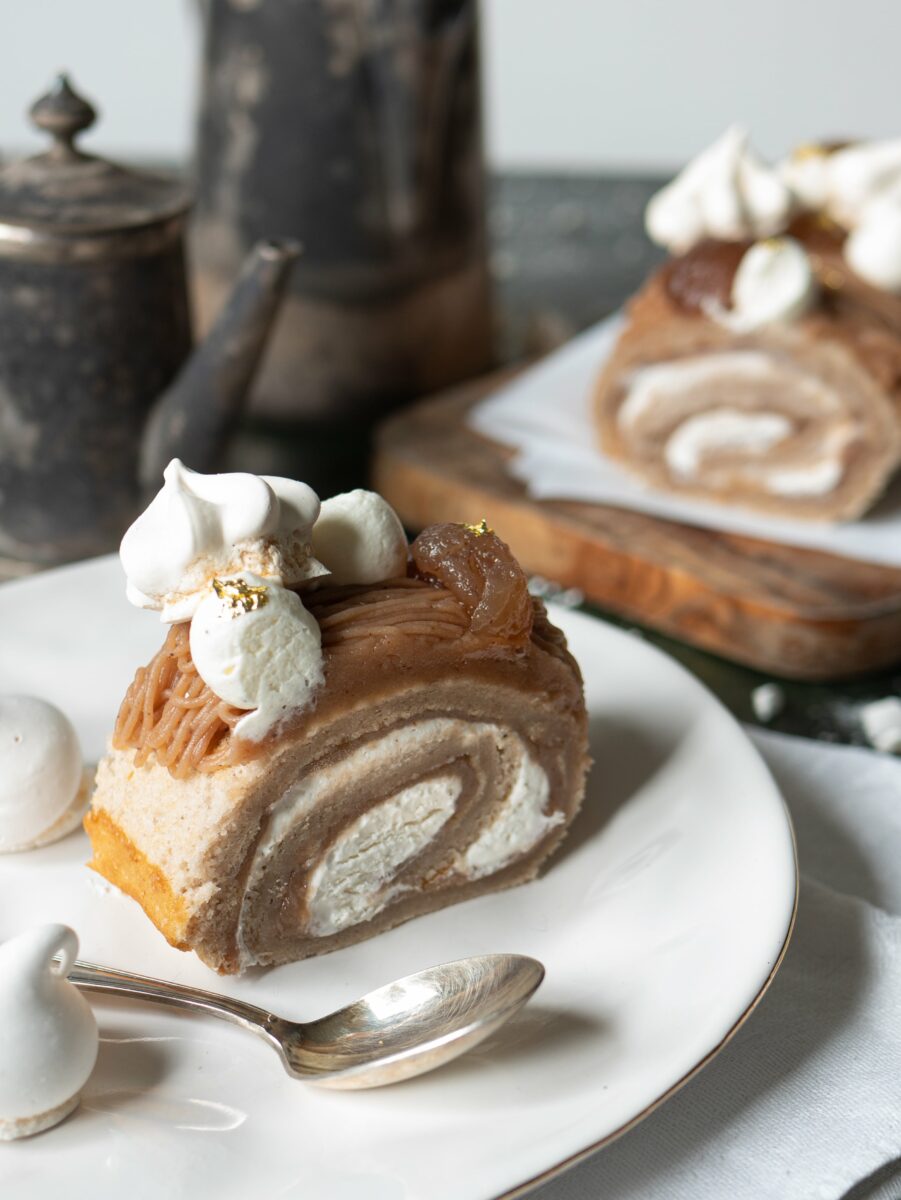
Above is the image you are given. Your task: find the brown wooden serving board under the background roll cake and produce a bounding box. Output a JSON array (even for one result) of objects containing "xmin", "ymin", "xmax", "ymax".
[{"xmin": 373, "ymin": 372, "xmax": 901, "ymax": 679}]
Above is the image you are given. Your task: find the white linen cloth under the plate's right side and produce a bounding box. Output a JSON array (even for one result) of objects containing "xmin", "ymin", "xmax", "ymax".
[{"xmin": 530, "ymin": 731, "xmax": 901, "ymax": 1200}]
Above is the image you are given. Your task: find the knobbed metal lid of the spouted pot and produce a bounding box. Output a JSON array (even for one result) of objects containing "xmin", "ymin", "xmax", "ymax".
[{"xmin": 0, "ymin": 74, "xmax": 191, "ymax": 256}]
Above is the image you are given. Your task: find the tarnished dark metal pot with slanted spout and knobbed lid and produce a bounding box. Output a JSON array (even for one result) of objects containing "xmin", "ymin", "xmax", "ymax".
[{"xmin": 0, "ymin": 76, "xmax": 298, "ymax": 570}]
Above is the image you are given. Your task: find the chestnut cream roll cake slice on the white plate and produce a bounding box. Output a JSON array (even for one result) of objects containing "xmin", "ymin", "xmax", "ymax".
[{"xmin": 86, "ymin": 463, "xmax": 588, "ymax": 972}]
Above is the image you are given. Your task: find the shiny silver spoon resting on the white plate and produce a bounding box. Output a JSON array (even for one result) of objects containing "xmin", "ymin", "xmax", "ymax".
[{"xmin": 68, "ymin": 954, "xmax": 545, "ymax": 1088}]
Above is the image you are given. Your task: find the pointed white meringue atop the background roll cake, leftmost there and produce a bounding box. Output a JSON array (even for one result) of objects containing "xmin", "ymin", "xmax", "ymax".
[{"xmin": 644, "ymin": 126, "xmax": 794, "ymax": 254}]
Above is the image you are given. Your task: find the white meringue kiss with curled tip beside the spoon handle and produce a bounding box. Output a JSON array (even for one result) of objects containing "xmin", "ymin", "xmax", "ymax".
[{"xmin": 0, "ymin": 925, "xmax": 100, "ymax": 1141}]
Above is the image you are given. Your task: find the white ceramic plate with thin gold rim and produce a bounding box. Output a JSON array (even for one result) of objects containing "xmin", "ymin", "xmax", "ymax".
[{"xmin": 0, "ymin": 559, "xmax": 795, "ymax": 1200}]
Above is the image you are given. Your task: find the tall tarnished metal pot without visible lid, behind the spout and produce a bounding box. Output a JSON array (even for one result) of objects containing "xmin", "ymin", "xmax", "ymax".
[{"xmin": 192, "ymin": 0, "xmax": 493, "ymax": 427}]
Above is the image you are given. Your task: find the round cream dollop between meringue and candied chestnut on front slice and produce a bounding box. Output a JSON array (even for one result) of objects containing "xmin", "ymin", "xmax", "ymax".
[{"xmin": 313, "ymin": 488, "xmax": 408, "ymax": 583}]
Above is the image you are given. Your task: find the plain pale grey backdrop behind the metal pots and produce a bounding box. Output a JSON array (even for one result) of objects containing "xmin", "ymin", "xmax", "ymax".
[{"xmin": 0, "ymin": 0, "xmax": 901, "ymax": 169}]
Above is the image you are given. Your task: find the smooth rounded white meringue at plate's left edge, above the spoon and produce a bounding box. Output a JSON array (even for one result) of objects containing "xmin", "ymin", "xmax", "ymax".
[{"xmin": 0, "ymin": 696, "xmax": 90, "ymax": 853}]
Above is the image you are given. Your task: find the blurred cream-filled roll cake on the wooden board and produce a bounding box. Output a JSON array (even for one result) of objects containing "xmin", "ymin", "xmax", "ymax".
[{"xmin": 595, "ymin": 127, "xmax": 901, "ymax": 521}]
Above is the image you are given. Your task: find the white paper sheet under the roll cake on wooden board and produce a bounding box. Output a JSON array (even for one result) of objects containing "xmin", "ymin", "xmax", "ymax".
[{"xmin": 469, "ymin": 317, "xmax": 901, "ymax": 566}]
